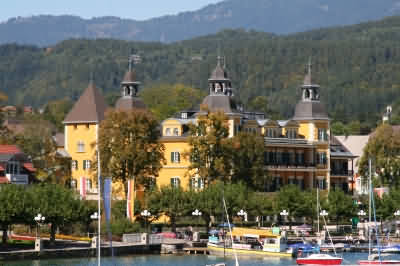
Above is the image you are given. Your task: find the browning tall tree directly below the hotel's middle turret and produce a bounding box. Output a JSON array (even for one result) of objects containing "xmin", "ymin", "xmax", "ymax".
[{"xmin": 185, "ymin": 109, "xmax": 232, "ymax": 184}]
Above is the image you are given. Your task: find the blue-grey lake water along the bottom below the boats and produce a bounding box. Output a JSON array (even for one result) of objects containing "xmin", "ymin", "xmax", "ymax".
[{"xmin": 0, "ymin": 253, "xmax": 400, "ymax": 266}]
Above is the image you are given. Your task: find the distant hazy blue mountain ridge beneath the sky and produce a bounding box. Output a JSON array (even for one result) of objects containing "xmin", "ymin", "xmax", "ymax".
[{"xmin": 0, "ymin": 0, "xmax": 400, "ymax": 46}]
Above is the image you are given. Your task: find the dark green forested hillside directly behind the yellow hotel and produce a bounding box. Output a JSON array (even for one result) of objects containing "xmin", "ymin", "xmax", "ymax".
[{"xmin": 0, "ymin": 17, "xmax": 400, "ymax": 128}]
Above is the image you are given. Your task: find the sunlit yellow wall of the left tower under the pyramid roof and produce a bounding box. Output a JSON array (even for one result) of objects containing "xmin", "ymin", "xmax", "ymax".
[{"xmin": 65, "ymin": 124, "xmax": 97, "ymax": 189}]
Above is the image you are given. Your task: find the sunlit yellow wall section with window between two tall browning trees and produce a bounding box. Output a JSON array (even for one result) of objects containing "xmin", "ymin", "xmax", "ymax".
[{"xmin": 157, "ymin": 139, "xmax": 190, "ymax": 189}]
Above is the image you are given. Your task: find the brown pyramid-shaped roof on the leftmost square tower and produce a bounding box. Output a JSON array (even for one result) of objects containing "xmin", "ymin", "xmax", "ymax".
[{"xmin": 64, "ymin": 81, "xmax": 107, "ymax": 124}]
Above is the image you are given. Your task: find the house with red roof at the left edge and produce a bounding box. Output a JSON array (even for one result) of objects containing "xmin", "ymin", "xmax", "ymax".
[{"xmin": 0, "ymin": 145, "xmax": 36, "ymax": 185}]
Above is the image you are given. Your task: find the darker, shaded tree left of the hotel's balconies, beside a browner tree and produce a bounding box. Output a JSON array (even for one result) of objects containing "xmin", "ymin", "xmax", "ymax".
[{"xmin": 232, "ymin": 132, "xmax": 268, "ymax": 189}]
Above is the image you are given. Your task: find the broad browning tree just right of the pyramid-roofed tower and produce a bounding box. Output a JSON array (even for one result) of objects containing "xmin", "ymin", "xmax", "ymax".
[{"xmin": 98, "ymin": 110, "xmax": 165, "ymax": 195}]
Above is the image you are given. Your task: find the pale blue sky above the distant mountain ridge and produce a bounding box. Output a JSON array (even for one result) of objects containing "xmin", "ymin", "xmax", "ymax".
[{"xmin": 0, "ymin": 0, "xmax": 222, "ymax": 22}]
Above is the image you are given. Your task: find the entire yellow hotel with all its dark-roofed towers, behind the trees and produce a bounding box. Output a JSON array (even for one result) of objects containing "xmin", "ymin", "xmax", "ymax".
[{"xmin": 64, "ymin": 58, "xmax": 354, "ymax": 199}]
